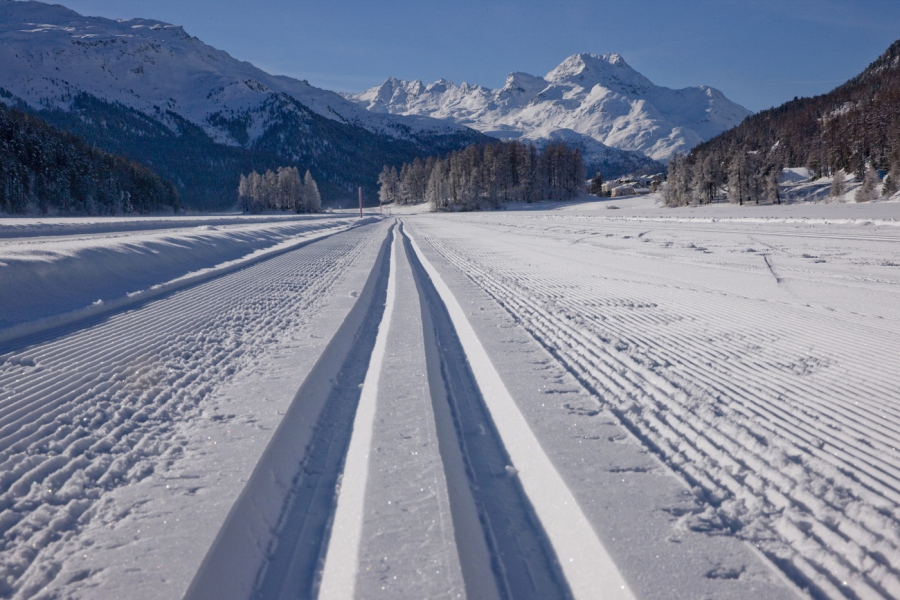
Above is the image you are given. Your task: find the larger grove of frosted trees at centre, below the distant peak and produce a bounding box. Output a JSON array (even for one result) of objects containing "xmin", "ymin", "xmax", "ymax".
[{"xmin": 378, "ymin": 142, "xmax": 585, "ymax": 211}]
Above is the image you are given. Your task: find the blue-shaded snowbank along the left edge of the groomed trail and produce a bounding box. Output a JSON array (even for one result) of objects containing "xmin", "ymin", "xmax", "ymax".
[{"xmin": 0, "ymin": 218, "xmax": 370, "ymax": 341}]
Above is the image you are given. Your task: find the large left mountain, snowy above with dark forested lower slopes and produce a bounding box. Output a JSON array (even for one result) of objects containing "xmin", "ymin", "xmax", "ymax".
[{"xmin": 0, "ymin": 0, "xmax": 483, "ymax": 208}]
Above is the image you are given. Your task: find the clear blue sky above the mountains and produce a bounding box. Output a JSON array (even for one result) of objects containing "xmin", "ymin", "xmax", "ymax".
[{"xmin": 54, "ymin": 0, "xmax": 900, "ymax": 111}]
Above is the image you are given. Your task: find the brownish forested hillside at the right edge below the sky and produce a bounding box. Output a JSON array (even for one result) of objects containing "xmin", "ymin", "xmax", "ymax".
[{"xmin": 666, "ymin": 41, "xmax": 900, "ymax": 205}]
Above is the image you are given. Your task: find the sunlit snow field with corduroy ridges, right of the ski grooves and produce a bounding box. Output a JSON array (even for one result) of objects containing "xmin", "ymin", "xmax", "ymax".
[{"xmin": 406, "ymin": 207, "xmax": 900, "ymax": 598}]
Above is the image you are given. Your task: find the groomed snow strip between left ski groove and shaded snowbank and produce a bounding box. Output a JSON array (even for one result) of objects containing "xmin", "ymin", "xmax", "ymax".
[{"xmin": 0, "ymin": 220, "xmax": 394, "ymax": 598}]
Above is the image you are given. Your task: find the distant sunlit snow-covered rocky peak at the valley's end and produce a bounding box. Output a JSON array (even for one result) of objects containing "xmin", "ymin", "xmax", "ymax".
[{"xmin": 347, "ymin": 54, "xmax": 751, "ymax": 160}]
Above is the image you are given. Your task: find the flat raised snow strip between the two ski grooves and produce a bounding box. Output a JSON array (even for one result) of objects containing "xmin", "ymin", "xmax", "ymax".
[{"xmin": 348, "ymin": 224, "xmax": 464, "ymax": 599}]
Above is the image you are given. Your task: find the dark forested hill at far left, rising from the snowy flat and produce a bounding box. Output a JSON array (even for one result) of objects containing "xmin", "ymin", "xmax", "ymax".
[{"xmin": 0, "ymin": 103, "xmax": 181, "ymax": 215}]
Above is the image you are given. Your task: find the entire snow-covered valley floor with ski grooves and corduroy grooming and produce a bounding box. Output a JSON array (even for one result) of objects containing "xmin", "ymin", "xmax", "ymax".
[{"xmin": 0, "ymin": 196, "xmax": 900, "ymax": 599}]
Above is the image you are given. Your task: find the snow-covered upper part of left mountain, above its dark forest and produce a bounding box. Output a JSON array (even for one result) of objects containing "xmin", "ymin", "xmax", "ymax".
[{"xmin": 0, "ymin": 0, "xmax": 478, "ymax": 146}]
